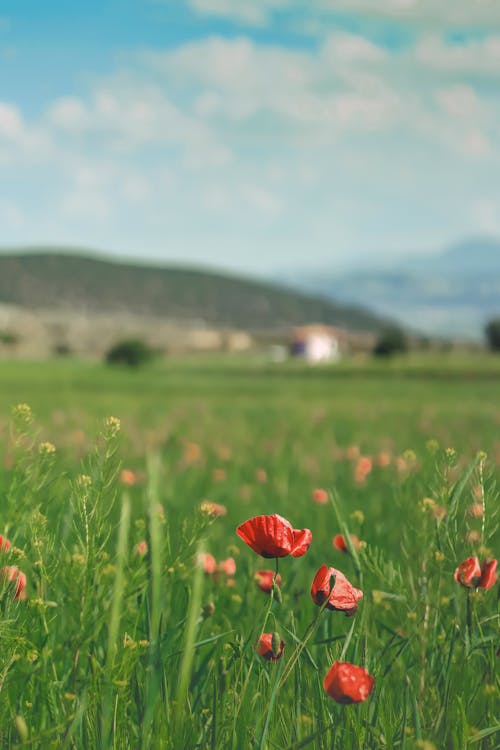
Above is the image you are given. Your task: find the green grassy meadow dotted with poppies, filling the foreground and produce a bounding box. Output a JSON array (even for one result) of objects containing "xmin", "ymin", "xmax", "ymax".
[{"xmin": 0, "ymin": 356, "xmax": 500, "ymax": 750}]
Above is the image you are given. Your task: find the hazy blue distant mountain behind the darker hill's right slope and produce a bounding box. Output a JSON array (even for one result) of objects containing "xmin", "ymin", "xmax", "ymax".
[{"xmin": 288, "ymin": 239, "xmax": 500, "ymax": 339}]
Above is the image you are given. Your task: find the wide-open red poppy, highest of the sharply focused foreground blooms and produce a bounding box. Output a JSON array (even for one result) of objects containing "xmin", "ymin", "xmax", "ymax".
[{"xmin": 236, "ymin": 513, "xmax": 312, "ymax": 557}]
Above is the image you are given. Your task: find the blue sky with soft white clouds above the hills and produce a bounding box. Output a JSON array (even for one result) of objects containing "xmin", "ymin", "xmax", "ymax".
[{"xmin": 0, "ymin": 0, "xmax": 500, "ymax": 273}]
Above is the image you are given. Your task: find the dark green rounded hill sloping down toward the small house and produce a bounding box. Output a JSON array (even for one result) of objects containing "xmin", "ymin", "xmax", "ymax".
[{"xmin": 0, "ymin": 250, "xmax": 383, "ymax": 331}]
